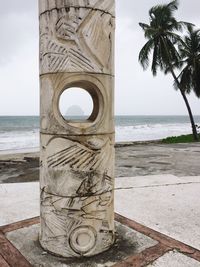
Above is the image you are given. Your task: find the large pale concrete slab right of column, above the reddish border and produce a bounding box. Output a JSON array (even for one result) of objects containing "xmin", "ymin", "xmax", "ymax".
[{"xmin": 115, "ymin": 175, "xmax": 200, "ymax": 249}]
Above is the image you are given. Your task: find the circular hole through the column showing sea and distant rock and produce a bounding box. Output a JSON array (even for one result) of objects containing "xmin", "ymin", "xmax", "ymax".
[{"xmin": 59, "ymin": 87, "xmax": 94, "ymax": 122}]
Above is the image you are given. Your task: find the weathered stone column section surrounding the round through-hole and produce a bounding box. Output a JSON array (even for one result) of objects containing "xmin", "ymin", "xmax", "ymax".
[{"xmin": 40, "ymin": 72, "xmax": 114, "ymax": 136}]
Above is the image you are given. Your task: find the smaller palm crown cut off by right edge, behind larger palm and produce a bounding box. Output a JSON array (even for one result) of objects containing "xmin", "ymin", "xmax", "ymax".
[{"xmin": 178, "ymin": 25, "xmax": 200, "ymax": 98}]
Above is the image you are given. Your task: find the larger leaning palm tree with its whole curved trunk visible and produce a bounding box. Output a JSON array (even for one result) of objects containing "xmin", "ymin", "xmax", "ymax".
[{"xmin": 139, "ymin": 0, "xmax": 198, "ymax": 141}]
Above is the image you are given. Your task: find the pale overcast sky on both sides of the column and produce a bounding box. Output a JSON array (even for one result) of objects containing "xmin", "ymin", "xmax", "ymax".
[{"xmin": 0, "ymin": 0, "xmax": 200, "ymax": 115}]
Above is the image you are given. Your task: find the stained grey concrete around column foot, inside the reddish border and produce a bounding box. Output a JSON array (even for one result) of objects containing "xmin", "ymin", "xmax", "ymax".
[{"xmin": 6, "ymin": 223, "xmax": 158, "ymax": 267}]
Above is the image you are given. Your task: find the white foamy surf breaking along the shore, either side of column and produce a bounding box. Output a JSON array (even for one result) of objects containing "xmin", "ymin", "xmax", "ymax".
[{"xmin": 0, "ymin": 123, "xmax": 197, "ymax": 151}]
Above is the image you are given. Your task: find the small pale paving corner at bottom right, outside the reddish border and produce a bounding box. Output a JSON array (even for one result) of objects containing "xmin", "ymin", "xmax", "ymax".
[{"xmin": 147, "ymin": 251, "xmax": 200, "ymax": 267}]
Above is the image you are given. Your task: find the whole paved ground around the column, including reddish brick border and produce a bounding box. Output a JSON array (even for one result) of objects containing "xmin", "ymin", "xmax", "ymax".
[{"xmin": 0, "ymin": 175, "xmax": 200, "ymax": 267}]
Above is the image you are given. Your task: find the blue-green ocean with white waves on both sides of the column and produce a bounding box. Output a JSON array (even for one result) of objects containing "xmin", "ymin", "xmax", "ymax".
[{"xmin": 0, "ymin": 116, "xmax": 200, "ymax": 151}]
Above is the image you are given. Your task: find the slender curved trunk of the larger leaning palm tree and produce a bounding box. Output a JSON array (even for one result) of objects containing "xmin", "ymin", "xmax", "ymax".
[{"xmin": 163, "ymin": 40, "xmax": 199, "ymax": 141}]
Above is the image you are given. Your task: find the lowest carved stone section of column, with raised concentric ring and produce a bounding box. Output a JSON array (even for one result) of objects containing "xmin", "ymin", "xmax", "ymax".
[{"xmin": 41, "ymin": 184, "xmax": 114, "ymax": 257}]
